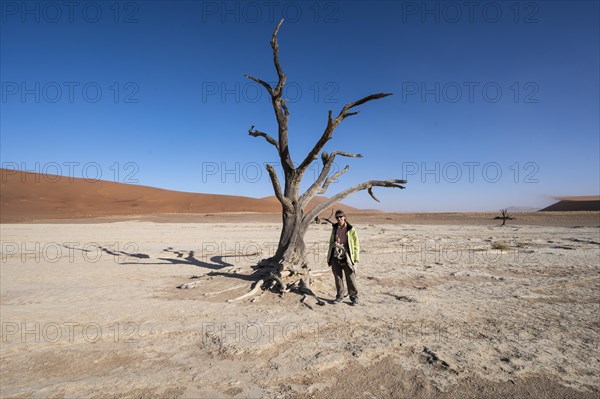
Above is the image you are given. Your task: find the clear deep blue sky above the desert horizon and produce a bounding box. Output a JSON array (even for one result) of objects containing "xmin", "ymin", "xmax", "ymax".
[{"xmin": 0, "ymin": 0, "xmax": 600, "ymax": 212}]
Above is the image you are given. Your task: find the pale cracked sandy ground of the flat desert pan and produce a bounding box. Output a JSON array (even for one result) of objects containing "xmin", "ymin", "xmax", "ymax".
[{"xmin": 0, "ymin": 220, "xmax": 600, "ymax": 398}]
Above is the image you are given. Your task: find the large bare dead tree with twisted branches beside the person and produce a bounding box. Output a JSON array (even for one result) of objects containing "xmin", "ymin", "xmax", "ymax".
[{"xmin": 239, "ymin": 19, "xmax": 406, "ymax": 296}]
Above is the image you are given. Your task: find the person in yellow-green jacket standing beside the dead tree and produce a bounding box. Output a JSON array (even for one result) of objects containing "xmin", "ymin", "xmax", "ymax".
[{"xmin": 327, "ymin": 210, "xmax": 360, "ymax": 305}]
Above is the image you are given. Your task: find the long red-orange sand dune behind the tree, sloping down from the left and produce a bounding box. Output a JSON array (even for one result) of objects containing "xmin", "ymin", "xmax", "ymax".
[{"xmin": 0, "ymin": 168, "xmax": 358, "ymax": 223}]
